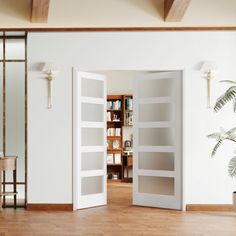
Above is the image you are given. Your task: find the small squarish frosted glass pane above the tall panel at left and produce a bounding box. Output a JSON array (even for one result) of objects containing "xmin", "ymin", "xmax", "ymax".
[{"xmin": 6, "ymin": 39, "xmax": 25, "ymax": 60}]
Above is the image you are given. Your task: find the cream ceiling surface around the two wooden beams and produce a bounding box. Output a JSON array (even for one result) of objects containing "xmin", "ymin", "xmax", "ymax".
[{"xmin": 0, "ymin": 0, "xmax": 236, "ymax": 28}]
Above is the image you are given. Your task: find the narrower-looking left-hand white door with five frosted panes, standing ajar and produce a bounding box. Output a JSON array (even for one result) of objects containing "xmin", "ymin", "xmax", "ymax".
[{"xmin": 73, "ymin": 69, "xmax": 107, "ymax": 210}]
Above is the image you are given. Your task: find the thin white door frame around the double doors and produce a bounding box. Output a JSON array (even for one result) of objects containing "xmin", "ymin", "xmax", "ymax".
[{"xmin": 72, "ymin": 66, "xmax": 187, "ymax": 211}]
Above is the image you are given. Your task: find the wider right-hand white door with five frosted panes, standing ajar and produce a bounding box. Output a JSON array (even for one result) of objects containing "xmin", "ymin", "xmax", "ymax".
[{"xmin": 133, "ymin": 71, "xmax": 182, "ymax": 209}]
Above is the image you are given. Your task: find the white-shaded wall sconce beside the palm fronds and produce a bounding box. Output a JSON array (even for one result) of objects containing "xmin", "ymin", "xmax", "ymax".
[{"xmin": 201, "ymin": 61, "xmax": 217, "ymax": 108}]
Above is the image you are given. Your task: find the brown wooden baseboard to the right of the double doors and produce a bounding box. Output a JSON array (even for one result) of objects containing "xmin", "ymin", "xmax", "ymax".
[{"xmin": 186, "ymin": 204, "xmax": 234, "ymax": 211}]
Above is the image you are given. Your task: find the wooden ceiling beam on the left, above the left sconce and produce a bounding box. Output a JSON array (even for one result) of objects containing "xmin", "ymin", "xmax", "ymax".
[{"xmin": 31, "ymin": 0, "xmax": 50, "ymax": 23}]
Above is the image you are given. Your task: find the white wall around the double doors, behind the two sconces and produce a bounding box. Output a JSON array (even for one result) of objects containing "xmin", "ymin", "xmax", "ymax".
[{"xmin": 28, "ymin": 31, "xmax": 236, "ymax": 203}]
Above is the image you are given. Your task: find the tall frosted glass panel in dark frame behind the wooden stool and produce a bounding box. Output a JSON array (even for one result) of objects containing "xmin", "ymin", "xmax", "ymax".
[{"xmin": 6, "ymin": 62, "xmax": 25, "ymax": 182}]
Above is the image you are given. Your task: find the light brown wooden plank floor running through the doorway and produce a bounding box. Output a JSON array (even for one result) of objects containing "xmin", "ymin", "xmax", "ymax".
[{"xmin": 0, "ymin": 184, "xmax": 236, "ymax": 236}]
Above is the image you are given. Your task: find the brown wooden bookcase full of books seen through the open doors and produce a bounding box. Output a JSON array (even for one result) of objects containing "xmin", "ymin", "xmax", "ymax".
[{"xmin": 107, "ymin": 95, "xmax": 133, "ymax": 181}]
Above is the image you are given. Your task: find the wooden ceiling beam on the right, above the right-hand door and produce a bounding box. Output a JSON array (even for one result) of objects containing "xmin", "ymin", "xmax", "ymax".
[{"xmin": 164, "ymin": 0, "xmax": 191, "ymax": 22}]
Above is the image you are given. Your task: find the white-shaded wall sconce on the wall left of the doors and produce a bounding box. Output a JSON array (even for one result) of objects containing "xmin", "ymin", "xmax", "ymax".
[{"xmin": 42, "ymin": 62, "xmax": 57, "ymax": 109}]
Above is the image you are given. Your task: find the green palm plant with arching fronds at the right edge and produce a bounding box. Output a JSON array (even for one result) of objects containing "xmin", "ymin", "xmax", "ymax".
[{"xmin": 207, "ymin": 80, "xmax": 236, "ymax": 211}]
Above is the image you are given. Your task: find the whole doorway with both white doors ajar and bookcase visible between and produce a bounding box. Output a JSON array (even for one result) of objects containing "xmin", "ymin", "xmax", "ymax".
[{"xmin": 73, "ymin": 70, "xmax": 182, "ymax": 209}]
